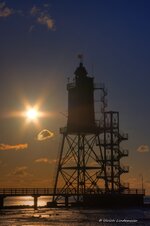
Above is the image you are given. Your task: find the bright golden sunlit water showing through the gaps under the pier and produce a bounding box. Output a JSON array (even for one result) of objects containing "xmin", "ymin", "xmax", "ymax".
[{"xmin": 4, "ymin": 196, "xmax": 51, "ymax": 206}]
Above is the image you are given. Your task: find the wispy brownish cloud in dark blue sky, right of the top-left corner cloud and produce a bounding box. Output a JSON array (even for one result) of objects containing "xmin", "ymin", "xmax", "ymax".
[{"xmin": 30, "ymin": 5, "xmax": 55, "ymax": 30}]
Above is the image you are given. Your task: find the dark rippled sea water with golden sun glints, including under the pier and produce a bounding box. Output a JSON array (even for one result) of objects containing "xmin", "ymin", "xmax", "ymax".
[{"xmin": 0, "ymin": 197, "xmax": 150, "ymax": 226}]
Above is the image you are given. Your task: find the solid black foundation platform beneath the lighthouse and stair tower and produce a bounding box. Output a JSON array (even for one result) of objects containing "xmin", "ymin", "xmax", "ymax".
[{"xmin": 47, "ymin": 193, "xmax": 144, "ymax": 209}]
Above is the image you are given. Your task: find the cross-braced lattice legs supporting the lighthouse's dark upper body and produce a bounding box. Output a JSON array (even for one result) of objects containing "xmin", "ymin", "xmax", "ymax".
[{"xmin": 53, "ymin": 132, "xmax": 104, "ymax": 206}]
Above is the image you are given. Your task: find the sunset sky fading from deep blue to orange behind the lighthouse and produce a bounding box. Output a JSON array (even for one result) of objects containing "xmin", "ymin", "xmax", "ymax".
[{"xmin": 0, "ymin": 0, "xmax": 150, "ymax": 194}]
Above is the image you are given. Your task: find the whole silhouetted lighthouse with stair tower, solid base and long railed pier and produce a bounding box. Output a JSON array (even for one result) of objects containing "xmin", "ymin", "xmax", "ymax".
[{"xmin": 0, "ymin": 62, "xmax": 145, "ymax": 209}]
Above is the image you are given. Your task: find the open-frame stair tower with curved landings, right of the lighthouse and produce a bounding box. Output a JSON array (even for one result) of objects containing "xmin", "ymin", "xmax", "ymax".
[{"xmin": 99, "ymin": 111, "xmax": 129, "ymax": 192}]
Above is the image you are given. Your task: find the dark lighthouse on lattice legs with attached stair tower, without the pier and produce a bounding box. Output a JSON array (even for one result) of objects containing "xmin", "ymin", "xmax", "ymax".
[{"xmin": 53, "ymin": 63, "xmax": 128, "ymax": 206}]
